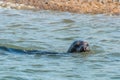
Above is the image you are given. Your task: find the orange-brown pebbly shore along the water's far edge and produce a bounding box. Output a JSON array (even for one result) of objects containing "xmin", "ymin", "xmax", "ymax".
[{"xmin": 0, "ymin": 0, "xmax": 120, "ymax": 15}]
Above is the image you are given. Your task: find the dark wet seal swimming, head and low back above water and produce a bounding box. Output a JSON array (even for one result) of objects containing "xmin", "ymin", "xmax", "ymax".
[{"xmin": 0, "ymin": 40, "xmax": 90, "ymax": 54}]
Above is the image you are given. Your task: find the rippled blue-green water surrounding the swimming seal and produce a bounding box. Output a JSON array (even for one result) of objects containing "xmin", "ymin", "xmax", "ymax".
[{"xmin": 0, "ymin": 8, "xmax": 120, "ymax": 80}]
